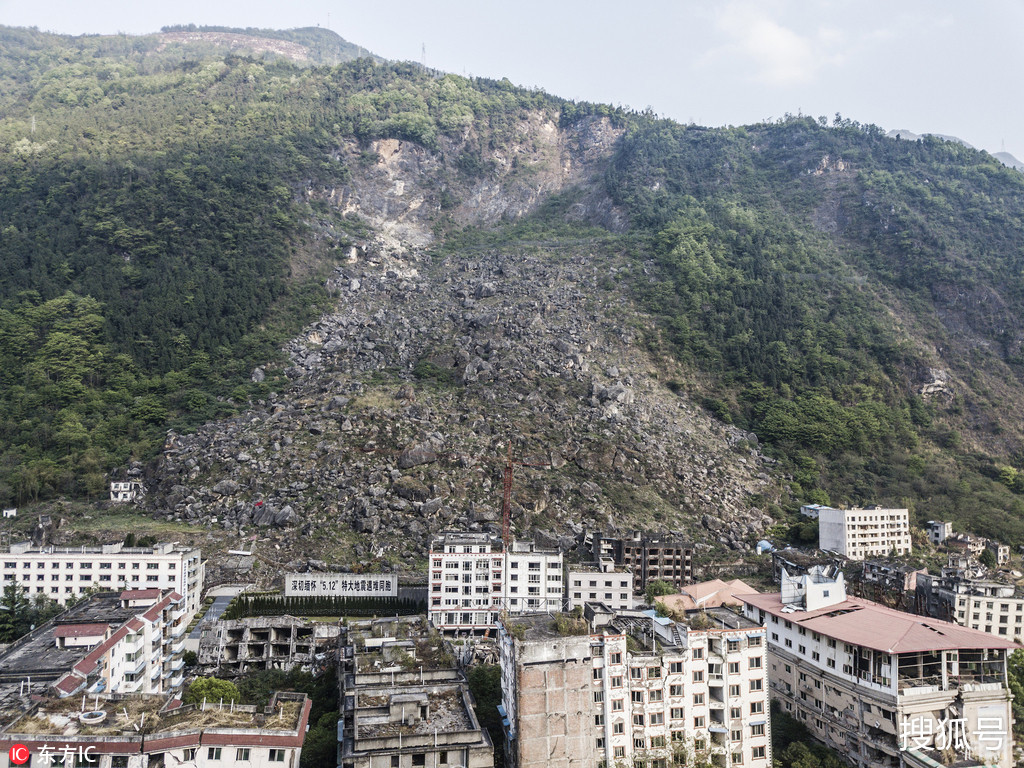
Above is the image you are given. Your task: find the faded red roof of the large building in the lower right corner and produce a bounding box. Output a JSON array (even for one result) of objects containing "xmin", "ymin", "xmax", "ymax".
[{"xmin": 742, "ymin": 593, "xmax": 1017, "ymax": 653}]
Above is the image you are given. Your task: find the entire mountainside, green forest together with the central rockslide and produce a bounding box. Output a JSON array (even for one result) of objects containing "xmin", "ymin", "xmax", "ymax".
[{"xmin": 0, "ymin": 29, "xmax": 1024, "ymax": 555}]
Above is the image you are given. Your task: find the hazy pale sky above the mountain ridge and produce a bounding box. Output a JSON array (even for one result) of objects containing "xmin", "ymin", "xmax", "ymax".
[{"xmin": 0, "ymin": 0, "xmax": 1024, "ymax": 159}]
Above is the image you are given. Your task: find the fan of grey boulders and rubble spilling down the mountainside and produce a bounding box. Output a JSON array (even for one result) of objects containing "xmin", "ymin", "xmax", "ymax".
[{"xmin": 150, "ymin": 219, "xmax": 771, "ymax": 566}]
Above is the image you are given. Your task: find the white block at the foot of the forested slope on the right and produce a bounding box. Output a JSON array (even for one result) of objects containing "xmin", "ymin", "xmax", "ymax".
[{"xmin": 818, "ymin": 507, "xmax": 911, "ymax": 560}]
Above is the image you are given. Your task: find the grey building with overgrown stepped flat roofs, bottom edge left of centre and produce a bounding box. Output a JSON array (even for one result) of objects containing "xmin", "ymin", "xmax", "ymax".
[{"xmin": 337, "ymin": 616, "xmax": 495, "ymax": 768}]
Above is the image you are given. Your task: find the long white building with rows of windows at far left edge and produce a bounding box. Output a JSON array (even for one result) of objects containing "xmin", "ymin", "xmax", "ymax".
[{"xmin": 0, "ymin": 542, "xmax": 205, "ymax": 621}]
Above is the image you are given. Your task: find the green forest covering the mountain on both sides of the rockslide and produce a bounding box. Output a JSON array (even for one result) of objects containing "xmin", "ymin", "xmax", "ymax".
[{"xmin": 0, "ymin": 28, "xmax": 1024, "ymax": 543}]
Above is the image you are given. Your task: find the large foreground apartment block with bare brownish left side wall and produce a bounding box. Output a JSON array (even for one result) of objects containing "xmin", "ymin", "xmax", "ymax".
[{"xmin": 499, "ymin": 606, "xmax": 771, "ymax": 768}]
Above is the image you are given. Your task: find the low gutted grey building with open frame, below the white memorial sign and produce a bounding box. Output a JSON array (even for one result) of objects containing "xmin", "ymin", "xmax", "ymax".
[{"xmin": 199, "ymin": 615, "xmax": 339, "ymax": 677}]
